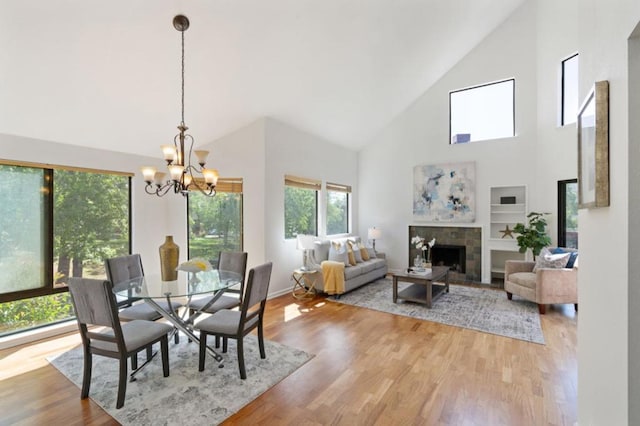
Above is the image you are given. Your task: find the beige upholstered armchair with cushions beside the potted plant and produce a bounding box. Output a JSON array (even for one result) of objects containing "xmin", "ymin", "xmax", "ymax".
[{"xmin": 504, "ymin": 247, "xmax": 578, "ymax": 314}]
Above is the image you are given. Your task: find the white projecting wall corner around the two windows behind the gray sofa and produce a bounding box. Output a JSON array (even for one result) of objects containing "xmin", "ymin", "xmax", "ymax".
[{"xmin": 203, "ymin": 118, "xmax": 358, "ymax": 295}]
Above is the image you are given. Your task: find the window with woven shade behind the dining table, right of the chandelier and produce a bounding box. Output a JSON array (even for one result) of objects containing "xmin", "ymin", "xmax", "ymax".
[{"xmin": 187, "ymin": 178, "xmax": 243, "ymax": 264}]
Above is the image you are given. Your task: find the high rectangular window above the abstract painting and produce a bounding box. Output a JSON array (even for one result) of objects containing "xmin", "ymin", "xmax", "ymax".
[{"xmin": 449, "ymin": 79, "xmax": 516, "ymax": 144}]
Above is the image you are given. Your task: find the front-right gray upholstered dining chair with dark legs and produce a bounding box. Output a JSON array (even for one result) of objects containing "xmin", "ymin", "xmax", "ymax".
[{"xmin": 195, "ymin": 262, "xmax": 273, "ymax": 379}]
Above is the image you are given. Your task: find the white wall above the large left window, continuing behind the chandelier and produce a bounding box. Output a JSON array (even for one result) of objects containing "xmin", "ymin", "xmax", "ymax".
[{"xmin": 0, "ymin": 134, "xmax": 175, "ymax": 271}]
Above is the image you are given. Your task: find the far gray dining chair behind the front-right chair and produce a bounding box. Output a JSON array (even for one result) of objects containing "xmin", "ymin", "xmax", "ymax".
[{"xmin": 189, "ymin": 251, "xmax": 248, "ymax": 314}]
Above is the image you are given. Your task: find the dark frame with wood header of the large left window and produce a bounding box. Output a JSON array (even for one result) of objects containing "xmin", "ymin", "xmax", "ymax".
[{"xmin": 0, "ymin": 159, "xmax": 134, "ymax": 303}]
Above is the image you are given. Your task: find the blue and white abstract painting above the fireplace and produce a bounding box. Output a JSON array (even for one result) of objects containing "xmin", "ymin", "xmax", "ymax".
[{"xmin": 413, "ymin": 162, "xmax": 476, "ymax": 222}]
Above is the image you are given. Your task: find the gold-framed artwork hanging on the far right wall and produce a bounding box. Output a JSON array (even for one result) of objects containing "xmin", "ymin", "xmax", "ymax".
[{"xmin": 577, "ymin": 80, "xmax": 609, "ymax": 209}]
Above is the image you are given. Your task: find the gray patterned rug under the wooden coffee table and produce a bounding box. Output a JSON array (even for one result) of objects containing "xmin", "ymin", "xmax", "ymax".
[{"xmin": 329, "ymin": 278, "xmax": 544, "ymax": 344}]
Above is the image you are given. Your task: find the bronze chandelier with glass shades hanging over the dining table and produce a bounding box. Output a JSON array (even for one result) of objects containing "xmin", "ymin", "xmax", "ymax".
[{"xmin": 142, "ymin": 15, "xmax": 218, "ymax": 197}]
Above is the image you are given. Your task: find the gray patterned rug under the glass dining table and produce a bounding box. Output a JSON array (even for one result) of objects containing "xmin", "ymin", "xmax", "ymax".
[{"xmin": 48, "ymin": 335, "xmax": 313, "ymax": 425}]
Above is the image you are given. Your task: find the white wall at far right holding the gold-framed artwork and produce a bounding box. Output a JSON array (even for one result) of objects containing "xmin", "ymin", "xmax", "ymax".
[{"xmin": 578, "ymin": 0, "xmax": 640, "ymax": 425}]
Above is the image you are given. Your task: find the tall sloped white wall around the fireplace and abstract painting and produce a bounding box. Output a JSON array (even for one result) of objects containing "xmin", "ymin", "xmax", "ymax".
[{"xmin": 358, "ymin": 2, "xmax": 539, "ymax": 282}]
